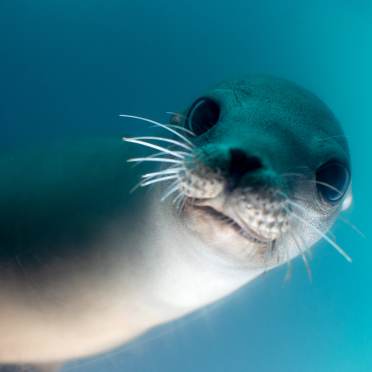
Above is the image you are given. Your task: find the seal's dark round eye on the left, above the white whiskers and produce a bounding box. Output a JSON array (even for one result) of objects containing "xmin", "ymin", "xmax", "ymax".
[{"xmin": 186, "ymin": 97, "xmax": 221, "ymax": 136}]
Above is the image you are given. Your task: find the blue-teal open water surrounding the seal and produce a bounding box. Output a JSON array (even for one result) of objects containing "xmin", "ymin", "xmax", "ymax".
[{"xmin": 0, "ymin": 0, "xmax": 372, "ymax": 372}]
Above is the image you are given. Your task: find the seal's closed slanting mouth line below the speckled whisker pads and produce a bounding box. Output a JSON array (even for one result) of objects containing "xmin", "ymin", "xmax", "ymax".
[{"xmin": 186, "ymin": 200, "xmax": 273, "ymax": 246}]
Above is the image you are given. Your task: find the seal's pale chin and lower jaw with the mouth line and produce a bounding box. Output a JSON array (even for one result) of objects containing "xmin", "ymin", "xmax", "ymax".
[{"xmin": 182, "ymin": 198, "xmax": 274, "ymax": 263}]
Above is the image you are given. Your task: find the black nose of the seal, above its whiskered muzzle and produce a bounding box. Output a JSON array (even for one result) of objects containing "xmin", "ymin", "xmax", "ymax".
[{"xmin": 228, "ymin": 148, "xmax": 263, "ymax": 188}]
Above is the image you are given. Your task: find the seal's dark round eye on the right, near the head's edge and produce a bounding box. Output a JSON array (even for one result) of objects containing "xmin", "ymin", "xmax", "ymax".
[{"xmin": 316, "ymin": 160, "xmax": 350, "ymax": 205}]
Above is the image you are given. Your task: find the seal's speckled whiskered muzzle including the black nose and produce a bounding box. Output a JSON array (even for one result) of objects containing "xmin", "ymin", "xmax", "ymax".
[{"xmin": 180, "ymin": 147, "xmax": 288, "ymax": 245}]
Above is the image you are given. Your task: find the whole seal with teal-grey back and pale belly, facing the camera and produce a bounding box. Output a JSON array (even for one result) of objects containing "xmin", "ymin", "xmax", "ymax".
[{"xmin": 0, "ymin": 76, "xmax": 351, "ymax": 370}]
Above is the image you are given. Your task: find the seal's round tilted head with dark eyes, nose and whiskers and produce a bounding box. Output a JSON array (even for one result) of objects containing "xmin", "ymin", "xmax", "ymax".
[{"xmin": 124, "ymin": 76, "xmax": 351, "ymax": 269}]
